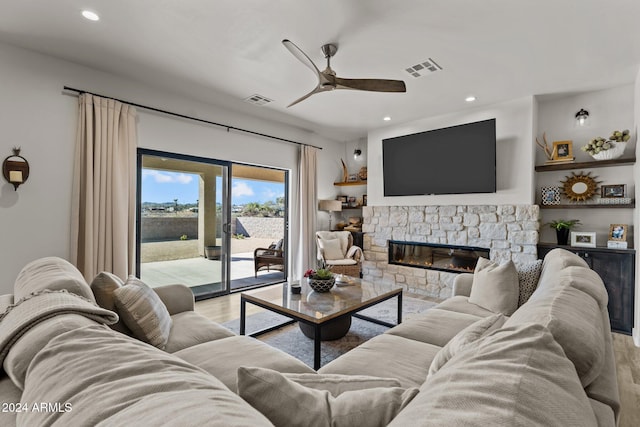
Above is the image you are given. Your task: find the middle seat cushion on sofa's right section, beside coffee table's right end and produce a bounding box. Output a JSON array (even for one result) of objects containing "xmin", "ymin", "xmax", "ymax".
[{"xmin": 385, "ymin": 309, "xmax": 480, "ymax": 347}]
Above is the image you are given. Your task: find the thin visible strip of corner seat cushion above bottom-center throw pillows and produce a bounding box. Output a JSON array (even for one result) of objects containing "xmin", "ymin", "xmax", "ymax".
[{"xmin": 284, "ymin": 374, "xmax": 400, "ymax": 396}]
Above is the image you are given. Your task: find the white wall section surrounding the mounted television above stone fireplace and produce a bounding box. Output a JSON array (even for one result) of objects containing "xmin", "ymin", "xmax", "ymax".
[{"xmin": 367, "ymin": 97, "xmax": 534, "ymax": 206}]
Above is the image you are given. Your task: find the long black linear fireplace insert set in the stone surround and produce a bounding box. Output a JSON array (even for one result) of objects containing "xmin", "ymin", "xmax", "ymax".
[{"xmin": 389, "ymin": 240, "xmax": 489, "ymax": 273}]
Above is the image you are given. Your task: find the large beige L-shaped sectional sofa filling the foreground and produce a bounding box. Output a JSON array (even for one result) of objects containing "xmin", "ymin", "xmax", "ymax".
[{"xmin": 0, "ymin": 249, "xmax": 619, "ymax": 427}]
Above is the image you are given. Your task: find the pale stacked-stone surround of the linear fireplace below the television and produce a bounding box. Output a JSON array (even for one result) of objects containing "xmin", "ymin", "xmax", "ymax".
[{"xmin": 362, "ymin": 205, "xmax": 540, "ymax": 299}]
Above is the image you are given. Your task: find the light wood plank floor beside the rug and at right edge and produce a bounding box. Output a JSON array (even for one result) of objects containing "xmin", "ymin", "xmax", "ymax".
[{"xmin": 196, "ymin": 293, "xmax": 640, "ymax": 427}]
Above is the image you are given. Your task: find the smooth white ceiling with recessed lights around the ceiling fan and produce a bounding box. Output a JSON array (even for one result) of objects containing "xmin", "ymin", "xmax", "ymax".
[{"xmin": 0, "ymin": 0, "xmax": 640, "ymax": 140}]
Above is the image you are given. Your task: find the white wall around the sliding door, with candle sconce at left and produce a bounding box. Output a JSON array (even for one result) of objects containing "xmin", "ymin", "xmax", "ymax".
[{"xmin": 0, "ymin": 44, "xmax": 344, "ymax": 294}]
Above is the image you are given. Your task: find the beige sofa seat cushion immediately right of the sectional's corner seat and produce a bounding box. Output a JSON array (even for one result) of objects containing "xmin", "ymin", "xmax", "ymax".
[{"xmin": 318, "ymin": 334, "xmax": 440, "ymax": 387}]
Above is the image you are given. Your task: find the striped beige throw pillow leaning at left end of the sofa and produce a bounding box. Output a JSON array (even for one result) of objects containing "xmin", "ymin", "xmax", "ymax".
[{"xmin": 113, "ymin": 276, "xmax": 171, "ymax": 349}]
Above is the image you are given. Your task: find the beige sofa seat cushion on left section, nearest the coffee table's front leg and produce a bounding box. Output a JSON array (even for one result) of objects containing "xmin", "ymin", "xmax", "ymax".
[{"xmin": 173, "ymin": 335, "xmax": 315, "ymax": 391}]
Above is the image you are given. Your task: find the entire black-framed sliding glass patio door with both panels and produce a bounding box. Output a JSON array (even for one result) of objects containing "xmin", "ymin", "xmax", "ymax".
[{"xmin": 136, "ymin": 149, "xmax": 289, "ymax": 299}]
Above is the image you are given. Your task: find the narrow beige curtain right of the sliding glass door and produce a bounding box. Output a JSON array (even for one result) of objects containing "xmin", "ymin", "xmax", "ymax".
[{"xmin": 293, "ymin": 145, "xmax": 318, "ymax": 280}]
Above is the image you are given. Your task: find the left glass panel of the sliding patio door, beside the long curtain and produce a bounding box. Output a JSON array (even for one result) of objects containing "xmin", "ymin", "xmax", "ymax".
[{"xmin": 137, "ymin": 149, "xmax": 230, "ymax": 299}]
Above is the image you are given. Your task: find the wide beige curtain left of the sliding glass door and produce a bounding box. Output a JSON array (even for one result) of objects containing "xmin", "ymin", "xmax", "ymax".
[{"xmin": 71, "ymin": 94, "xmax": 137, "ymax": 281}]
